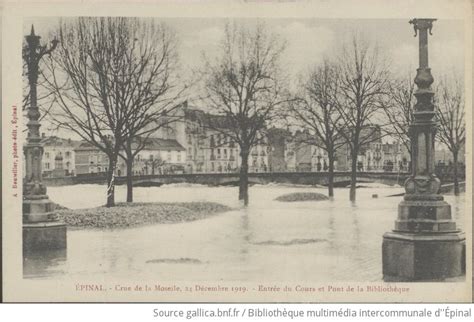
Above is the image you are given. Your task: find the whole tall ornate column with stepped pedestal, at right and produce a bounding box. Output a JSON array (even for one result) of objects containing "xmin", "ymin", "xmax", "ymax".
[{"xmin": 382, "ymin": 19, "xmax": 465, "ymax": 281}]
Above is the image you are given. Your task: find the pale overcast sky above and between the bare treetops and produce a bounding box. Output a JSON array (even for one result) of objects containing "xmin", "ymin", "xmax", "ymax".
[{"xmin": 24, "ymin": 18, "xmax": 464, "ymax": 142}]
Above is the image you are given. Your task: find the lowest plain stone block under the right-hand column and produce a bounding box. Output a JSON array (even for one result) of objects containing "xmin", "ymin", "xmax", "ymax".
[{"xmin": 382, "ymin": 232, "xmax": 466, "ymax": 281}]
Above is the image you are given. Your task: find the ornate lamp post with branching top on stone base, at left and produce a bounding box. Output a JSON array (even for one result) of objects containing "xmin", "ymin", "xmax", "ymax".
[{"xmin": 23, "ymin": 26, "xmax": 66, "ymax": 252}]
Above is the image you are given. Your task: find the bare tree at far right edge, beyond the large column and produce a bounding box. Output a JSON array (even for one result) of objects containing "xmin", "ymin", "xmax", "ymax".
[{"xmin": 435, "ymin": 76, "xmax": 466, "ymax": 195}]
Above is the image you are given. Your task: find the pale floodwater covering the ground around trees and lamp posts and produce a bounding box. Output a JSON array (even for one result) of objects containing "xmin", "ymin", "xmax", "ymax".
[{"xmin": 24, "ymin": 184, "xmax": 465, "ymax": 282}]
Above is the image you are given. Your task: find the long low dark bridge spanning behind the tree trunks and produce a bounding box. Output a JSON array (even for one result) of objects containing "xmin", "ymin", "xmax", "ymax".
[{"xmin": 43, "ymin": 172, "xmax": 409, "ymax": 187}]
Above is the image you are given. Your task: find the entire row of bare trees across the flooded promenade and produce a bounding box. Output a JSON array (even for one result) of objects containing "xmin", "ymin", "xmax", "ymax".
[{"xmin": 30, "ymin": 18, "xmax": 465, "ymax": 206}]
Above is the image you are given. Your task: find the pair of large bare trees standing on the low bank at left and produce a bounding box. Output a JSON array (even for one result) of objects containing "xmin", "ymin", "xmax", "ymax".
[{"xmin": 35, "ymin": 17, "xmax": 184, "ymax": 207}]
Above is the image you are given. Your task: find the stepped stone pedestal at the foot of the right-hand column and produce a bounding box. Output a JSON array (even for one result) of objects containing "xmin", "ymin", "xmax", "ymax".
[{"xmin": 382, "ymin": 192, "xmax": 466, "ymax": 281}]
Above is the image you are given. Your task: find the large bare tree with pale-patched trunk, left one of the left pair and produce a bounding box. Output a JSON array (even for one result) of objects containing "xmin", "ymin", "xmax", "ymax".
[{"xmin": 43, "ymin": 17, "xmax": 178, "ymax": 207}]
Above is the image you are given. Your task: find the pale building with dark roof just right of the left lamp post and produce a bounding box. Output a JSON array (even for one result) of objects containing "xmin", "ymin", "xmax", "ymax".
[{"xmin": 41, "ymin": 134, "xmax": 80, "ymax": 177}]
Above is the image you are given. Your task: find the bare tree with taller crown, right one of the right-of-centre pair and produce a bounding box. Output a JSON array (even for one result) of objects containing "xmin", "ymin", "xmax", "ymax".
[{"xmin": 336, "ymin": 36, "xmax": 389, "ymax": 201}]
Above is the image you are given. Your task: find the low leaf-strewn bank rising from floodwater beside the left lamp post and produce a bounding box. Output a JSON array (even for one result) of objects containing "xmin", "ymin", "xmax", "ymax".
[{"xmin": 57, "ymin": 202, "xmax": 231, "ymax": 228}]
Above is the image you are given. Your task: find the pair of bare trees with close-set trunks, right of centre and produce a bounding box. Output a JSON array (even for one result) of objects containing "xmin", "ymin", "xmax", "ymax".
[{"xmin": 289, "ymin": 36, "xmax": 390, "ymax": 201}]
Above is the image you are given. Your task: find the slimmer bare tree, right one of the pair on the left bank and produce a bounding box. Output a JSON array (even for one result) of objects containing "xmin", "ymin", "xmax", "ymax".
[{"xmin": 111, "ymin": 20, "xmax": 184, "ymax": 202}]
